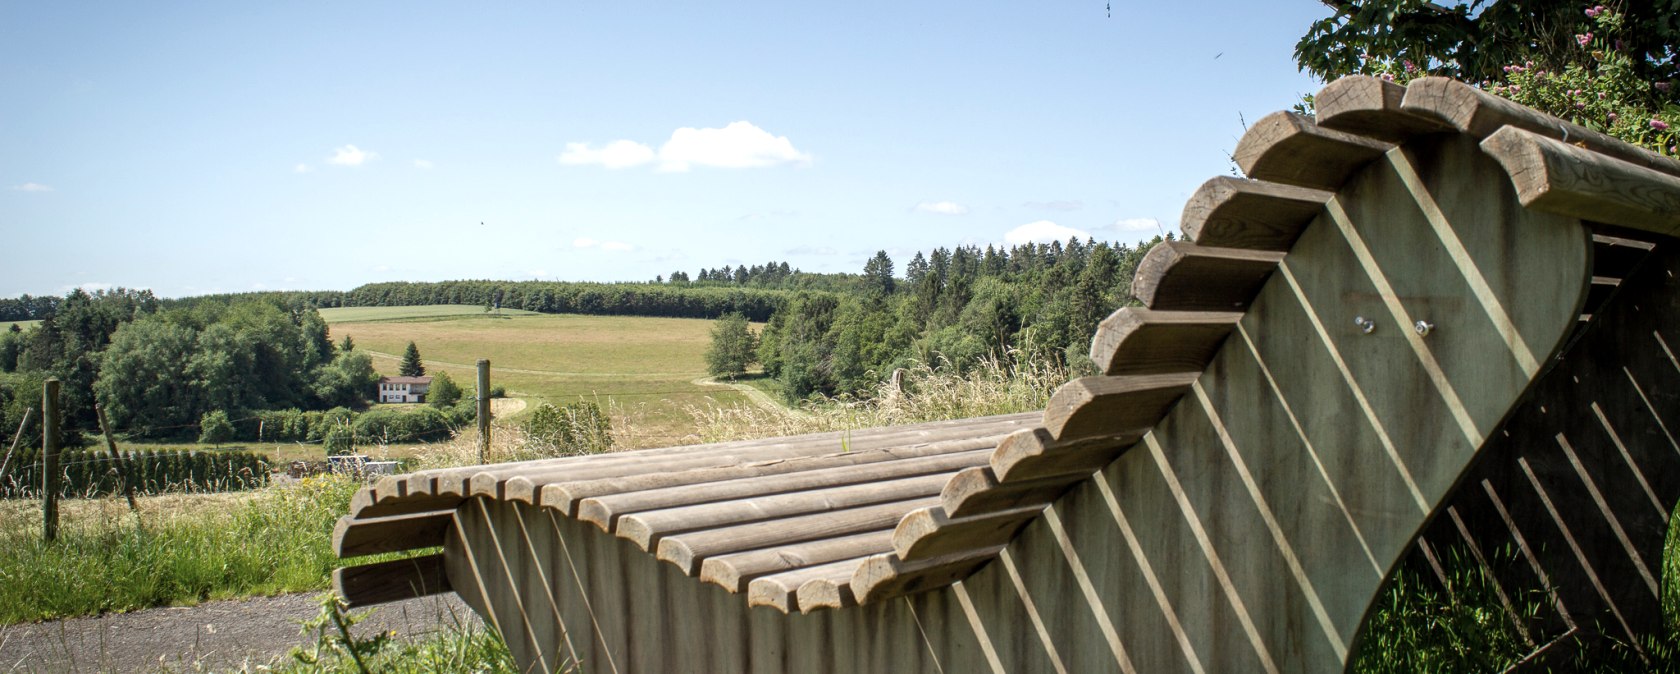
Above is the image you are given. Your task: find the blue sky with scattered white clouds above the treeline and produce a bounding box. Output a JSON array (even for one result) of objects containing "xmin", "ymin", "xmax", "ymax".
[{"xmin": 0, "ymin": 0, "xmax": 1329, "ymax": 296}]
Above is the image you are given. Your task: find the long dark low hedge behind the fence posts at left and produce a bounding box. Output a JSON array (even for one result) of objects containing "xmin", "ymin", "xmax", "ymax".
[{"xmin": 0, "ymin": 449, "xmax": 269, "ymax": 498}]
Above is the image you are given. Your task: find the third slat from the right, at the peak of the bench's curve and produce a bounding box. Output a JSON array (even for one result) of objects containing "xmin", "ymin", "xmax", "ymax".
[{"xmin": 1312, "ymin": 76, "xmax": 1453, "ymax": 143}]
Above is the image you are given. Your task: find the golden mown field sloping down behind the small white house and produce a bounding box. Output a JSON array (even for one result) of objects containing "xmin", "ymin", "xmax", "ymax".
[{"xmin": 321, "ymin": 306, "xmax": 746, "ymax": 447}]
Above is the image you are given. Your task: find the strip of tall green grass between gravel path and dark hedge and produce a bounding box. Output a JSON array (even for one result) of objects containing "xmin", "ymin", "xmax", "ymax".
[{"xmin": 0, "ymin": 476, "xmax": 360, "ymax": 624}]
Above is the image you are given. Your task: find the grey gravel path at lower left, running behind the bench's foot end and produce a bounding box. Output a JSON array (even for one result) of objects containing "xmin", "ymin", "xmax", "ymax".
[{"xmin": 0, "ymin": 592, "xmax": 480, "ymax": 672}]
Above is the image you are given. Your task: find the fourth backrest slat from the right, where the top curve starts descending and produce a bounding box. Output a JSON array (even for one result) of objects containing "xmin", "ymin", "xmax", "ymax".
[{"xmin": 1231, "ymin": 113, "xmax": 1391, "ymax": 192}]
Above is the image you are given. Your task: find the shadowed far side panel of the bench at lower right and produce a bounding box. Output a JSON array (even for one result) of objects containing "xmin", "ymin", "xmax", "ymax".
[{"xmin": 1408, "ymin": 240, "xmax": 1680, "ymax": 649}]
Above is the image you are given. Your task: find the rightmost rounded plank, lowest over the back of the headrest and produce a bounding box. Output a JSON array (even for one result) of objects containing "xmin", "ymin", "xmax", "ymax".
[{"xmin": 1482, "ymin": 126, "xmax": 1680, "ymax": 235}]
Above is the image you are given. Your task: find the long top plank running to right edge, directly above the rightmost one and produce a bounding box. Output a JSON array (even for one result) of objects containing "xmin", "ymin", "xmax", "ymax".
[{"xmin": 1401, "ymin": 77, "xmax": 1680, "ymax": 176}]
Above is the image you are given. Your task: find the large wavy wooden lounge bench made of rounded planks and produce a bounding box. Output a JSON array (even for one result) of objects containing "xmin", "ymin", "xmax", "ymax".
[{"xmin": 324, "ymin": 77, "xmax": 1680, "ymax": 672}]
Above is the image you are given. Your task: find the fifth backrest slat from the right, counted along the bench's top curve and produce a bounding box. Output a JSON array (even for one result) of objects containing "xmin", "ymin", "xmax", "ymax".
[{"xmin": 1178, "ymin": 175, "xmax": 1334, "ymax": 250}]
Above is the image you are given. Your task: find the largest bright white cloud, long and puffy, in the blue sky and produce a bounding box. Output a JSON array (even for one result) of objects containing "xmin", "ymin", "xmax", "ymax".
[{"xmin": 559, "ymin": 121, "xmax": 811, "ymax": 173}]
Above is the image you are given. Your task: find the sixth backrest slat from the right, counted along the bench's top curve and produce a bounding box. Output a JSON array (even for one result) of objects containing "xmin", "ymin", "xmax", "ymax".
[{"xmin": 1132, "ymin": 240, "xmax": 1284, "ymax": 311}]
